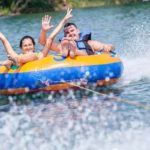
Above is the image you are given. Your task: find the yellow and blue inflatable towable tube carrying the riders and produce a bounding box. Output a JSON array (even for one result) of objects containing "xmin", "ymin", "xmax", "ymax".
[{"xmin": 0, "ymin": 53, "xmax": 123, "ymax": 94}]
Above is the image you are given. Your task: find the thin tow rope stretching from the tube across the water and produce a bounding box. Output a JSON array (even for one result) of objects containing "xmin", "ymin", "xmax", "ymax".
[{"xmin": 67, "ymin": 82, "xmax": 150, "ymax": 110}]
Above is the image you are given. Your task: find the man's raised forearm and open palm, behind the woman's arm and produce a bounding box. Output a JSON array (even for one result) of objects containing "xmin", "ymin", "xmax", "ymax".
[{"xmin": 39, "ymin": 15, "xmax": 53, "ymax": 45}]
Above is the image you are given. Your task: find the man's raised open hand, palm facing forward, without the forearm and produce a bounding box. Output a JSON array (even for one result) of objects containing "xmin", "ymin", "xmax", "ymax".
[{"xmin": 42, "ymin": 15, "xmax": 53, "ymax": 32}]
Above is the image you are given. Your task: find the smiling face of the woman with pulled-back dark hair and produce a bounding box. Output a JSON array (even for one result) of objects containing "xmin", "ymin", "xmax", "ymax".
[{"xmin": 21, "ymin": 38, "xmax": 35, "ymax": 53}]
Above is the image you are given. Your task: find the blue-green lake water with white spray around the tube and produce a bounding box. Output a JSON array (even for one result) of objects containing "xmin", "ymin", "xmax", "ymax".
[{"xmin": 0, "ymin": 3, "xmax": 150, "ymax": 150}]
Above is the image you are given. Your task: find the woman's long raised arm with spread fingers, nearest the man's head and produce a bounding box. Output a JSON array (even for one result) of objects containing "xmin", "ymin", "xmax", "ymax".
[{"xmin": 42, "ymin": 8, "xmax": 72, "ymax": 57}]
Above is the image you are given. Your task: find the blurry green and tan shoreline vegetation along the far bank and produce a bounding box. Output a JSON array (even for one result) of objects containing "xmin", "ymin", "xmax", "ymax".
[{"xmin": 0, "ymin": 0, "xmax": 148, "ymax": 14}]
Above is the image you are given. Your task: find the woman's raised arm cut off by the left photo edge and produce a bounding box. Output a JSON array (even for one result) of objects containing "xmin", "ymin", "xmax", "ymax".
[{"xmin": 0, "ymin": 32, "xmax": 18, "ymax": 57}]
